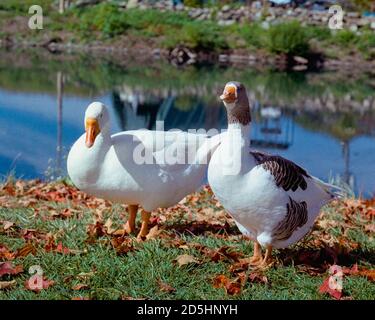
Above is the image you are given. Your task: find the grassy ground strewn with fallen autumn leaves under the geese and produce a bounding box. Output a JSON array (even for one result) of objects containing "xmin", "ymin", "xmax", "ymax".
[{"xmin": 0, "ymin": 181, "xmax": 375, "ymax": 300}]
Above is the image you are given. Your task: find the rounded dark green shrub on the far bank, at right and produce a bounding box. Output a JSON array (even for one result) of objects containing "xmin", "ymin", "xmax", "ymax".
[{"xmin": 267, "ymin": 21, "xmax": 309, "ymax": 55}]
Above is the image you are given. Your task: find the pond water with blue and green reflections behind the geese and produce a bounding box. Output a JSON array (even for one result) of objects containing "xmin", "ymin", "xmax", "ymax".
[{"xmin": 0, "ymin": 48, "xmax": 375, "ymax": 194}]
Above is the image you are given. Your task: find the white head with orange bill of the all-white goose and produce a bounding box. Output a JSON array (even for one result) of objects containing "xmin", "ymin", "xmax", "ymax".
[{"xmin": 85, "ymin": 102, "xmax": 109, "ymax": 148}]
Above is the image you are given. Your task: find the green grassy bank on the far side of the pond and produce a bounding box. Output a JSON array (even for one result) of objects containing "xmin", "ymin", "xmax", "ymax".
[{"xmin": 0, "ymin": 0, "xmax": 375, "ymax": 59}]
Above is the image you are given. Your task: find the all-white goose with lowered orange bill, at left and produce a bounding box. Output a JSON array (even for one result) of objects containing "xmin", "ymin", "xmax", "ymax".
[{"xmin": 67, "ymin": 102, "xmax": 220, "ymax": 238}]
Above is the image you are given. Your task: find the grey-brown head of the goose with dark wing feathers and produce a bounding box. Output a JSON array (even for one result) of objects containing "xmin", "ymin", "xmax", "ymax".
[{"xmin": 220, "ymin": 81, "xmax": 251, "ymax": 125}]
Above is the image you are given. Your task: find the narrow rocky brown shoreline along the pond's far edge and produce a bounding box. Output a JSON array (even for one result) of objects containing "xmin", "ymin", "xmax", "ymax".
[{"xmin": 0, "ymin": 37, "xmax": 375, "ymax": 75}]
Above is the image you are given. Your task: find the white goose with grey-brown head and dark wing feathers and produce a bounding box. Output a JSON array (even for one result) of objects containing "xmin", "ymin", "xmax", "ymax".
[{"xmin": 208, "ymin": 81, "xmax": 338, "ymax": 268}]
